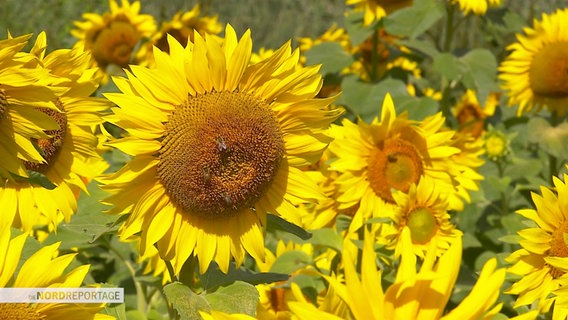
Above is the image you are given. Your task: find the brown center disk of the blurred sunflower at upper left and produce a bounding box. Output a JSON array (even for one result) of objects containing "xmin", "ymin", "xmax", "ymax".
[{"xmin": 93, "ymin": 21, "xmax": 140, "ymax": 68}]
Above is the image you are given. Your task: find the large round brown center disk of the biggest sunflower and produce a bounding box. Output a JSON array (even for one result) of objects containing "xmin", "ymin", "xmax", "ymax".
[{"xmin": 158, "ymin": 92, "xmax": 284, "ymax": 219}]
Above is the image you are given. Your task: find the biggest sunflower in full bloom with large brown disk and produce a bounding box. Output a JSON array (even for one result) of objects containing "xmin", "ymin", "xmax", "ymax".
[{"xmin": 101, "ymin": 25, "xmax": 340, "ymax": 273}]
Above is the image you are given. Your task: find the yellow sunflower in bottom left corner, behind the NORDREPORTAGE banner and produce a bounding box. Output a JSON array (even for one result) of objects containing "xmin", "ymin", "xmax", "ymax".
[{"xmin": 0, "ymin": 226, "xmax": 114, "ymax": 320}]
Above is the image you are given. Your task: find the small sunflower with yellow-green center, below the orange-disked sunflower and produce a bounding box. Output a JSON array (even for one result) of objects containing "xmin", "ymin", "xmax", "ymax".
[{"xmin": 380, "ymin": 177, "xmax": 462, "ymax": 258}]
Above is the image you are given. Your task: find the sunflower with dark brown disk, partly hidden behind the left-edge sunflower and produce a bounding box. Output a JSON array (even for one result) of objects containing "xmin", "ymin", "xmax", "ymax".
[{"xmin": 0, "ymin": 32, "xmax": 110, "ymax": 232}]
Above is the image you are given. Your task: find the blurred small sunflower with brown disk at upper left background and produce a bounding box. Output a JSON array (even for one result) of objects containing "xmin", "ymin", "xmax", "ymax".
[{"xmin": 71, "ymin": 0, "xmax": 156, "ymax": 78}]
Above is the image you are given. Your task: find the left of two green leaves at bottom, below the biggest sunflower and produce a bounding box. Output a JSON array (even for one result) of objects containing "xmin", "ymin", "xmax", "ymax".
[{"xmin": 164, "ymin": 282, "xmax": 211, "ymax": 320}]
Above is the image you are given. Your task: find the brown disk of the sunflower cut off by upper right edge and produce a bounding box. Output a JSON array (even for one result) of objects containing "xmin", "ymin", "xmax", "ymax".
[{"xmin": 530, "ymin": 42, "xmax": 568, "ymax": 98}]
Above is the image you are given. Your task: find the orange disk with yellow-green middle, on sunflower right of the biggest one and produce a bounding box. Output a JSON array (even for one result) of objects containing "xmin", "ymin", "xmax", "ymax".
[{"xmin": 368, "ymin": 139, "xmax": 424, "ymax": 203}]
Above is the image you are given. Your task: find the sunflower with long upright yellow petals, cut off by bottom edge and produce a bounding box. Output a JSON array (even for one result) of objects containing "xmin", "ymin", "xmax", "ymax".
[{"xmin": 316, "ymin": 229, "xmax": 505, "ymax": 320}]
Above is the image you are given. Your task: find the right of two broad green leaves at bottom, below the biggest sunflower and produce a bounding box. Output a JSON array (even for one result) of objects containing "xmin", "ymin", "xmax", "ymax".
[{"xmin": 205, "ymin": 281, "xmax": 259, "ymax": 316}]
